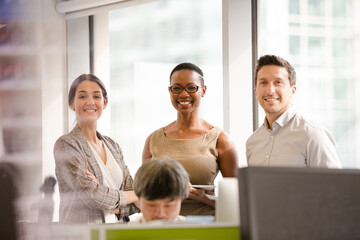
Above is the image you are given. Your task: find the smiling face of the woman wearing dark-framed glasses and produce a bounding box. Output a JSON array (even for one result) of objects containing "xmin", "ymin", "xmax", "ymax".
[{"xmin": 169, "ymin": 69, "xmax": 206, "ymax": 113}]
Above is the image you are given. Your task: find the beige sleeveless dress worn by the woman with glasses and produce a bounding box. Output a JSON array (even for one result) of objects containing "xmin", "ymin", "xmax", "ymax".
[{"xmin": 150, "ymin": 127, "xmax": 222, "ymax": 216}]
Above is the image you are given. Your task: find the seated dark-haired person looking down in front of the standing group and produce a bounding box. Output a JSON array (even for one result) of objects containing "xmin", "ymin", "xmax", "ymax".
[{"xmin": 130, "ymin": 159, "xmax": 189, "ymax": 223}]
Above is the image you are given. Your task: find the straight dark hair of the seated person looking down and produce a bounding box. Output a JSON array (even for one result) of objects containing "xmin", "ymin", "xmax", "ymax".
[{"xmin": 134, "ymin": 159, "xmax": 189, "ymax": 201}]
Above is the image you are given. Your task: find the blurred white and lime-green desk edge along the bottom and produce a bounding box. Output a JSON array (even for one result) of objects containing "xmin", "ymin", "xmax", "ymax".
[{"xmin": 20, "ymin": 223, "xmax": 240, "ymax": 240}]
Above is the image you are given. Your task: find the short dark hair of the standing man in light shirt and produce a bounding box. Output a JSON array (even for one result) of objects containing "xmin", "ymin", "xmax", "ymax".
[{"xmin": 255, "ymin": 55, "xmax": 296, "ymax": 86}]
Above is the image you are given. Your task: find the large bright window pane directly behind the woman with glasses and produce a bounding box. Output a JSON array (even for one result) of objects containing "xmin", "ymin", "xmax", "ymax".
[{"xmin": 109, "ymin": 0, "xmax": 223, "ymax": 173}]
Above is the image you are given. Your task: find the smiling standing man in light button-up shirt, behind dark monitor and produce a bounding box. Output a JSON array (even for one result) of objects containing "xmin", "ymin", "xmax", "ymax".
[{"xmin": 246, "ymin": 55, "xmax": 341, "ymax": 168}]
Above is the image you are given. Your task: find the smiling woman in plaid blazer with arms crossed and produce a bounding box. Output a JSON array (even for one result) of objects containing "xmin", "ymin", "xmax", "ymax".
[{"xmin": 54, "ymin": 74, "xmax": 139, "ymax": 223}]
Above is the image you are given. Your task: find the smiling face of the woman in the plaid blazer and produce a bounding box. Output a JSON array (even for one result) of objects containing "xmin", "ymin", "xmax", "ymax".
[{"xmin": 70, "ymin": 80, "xmax": 107, "ymax": 124}]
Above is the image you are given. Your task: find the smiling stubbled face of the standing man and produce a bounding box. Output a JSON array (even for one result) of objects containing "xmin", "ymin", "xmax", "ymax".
[{"xmin": 255, "ymin": 65, "xmax": 296, "ymax": 120}]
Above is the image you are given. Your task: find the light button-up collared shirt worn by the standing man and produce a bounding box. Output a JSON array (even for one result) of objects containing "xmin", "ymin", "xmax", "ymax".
[{"xmin": 246, "ymin": 106, "xmax": 341, "ymax": 168}]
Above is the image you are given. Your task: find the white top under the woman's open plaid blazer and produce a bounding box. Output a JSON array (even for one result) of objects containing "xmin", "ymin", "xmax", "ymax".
[{"xmin": 88, "ymin": 142, "xmax": 124, "ymax": 223}]
